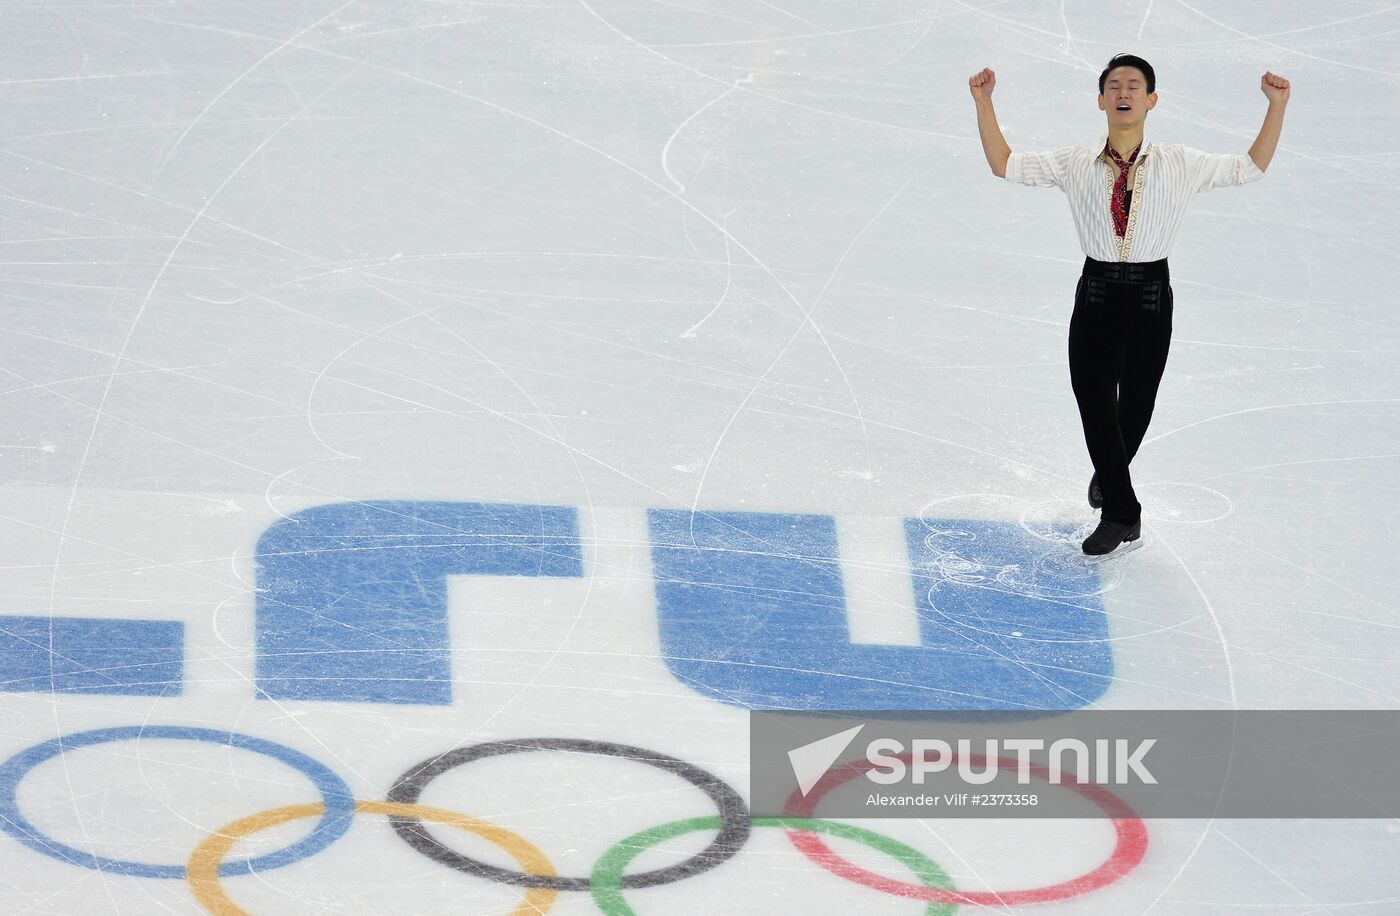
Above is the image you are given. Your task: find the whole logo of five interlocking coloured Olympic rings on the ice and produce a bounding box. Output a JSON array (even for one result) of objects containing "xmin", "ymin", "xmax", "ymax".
[{"xmin": 0, "ymin": 726, "xmax": 1148, "ymax": 916}]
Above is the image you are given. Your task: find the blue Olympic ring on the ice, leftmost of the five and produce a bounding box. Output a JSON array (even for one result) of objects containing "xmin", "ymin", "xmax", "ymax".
[{"xmin": 0, "ymin": 726, "xmax": 354, "ymax": 878}]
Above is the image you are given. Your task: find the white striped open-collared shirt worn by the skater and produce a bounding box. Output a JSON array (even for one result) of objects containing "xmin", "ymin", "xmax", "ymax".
[{"xmin": 1007, "ymin": 133, "xmax": 1264, "ymax": 262}]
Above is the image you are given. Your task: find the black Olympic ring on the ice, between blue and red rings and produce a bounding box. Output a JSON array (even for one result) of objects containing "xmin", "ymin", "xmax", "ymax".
[{"xmin": 388, "ymin": 738, "xmax": 752, "ymax": 891}]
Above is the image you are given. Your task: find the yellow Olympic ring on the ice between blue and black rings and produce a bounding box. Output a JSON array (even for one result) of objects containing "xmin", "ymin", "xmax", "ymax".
[{"xmin": 186, "ymin": 801, "xmax": 559, "ymax": 916}]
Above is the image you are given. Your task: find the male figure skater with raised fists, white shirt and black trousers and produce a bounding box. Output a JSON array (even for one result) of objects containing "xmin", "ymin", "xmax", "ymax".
[{"xmin": 967, "ymin": 55, "xmax": 1288, "ymax": 555}]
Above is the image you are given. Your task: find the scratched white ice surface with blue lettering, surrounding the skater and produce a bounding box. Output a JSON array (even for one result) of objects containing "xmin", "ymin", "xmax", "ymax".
[{"xmin": 0, "ymin": 0, "xmax": 1400, "ymax": 916}]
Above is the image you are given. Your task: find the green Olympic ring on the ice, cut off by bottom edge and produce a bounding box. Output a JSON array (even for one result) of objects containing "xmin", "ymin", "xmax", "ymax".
[{"xmin": 588, "ymin": 815, "xmax": 958, "ymax": 916}]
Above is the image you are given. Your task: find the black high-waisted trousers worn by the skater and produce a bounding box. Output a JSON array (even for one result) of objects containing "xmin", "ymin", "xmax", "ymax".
[{"xmin": 1070, "ymin": 258, "xmax": 1172, "ymax": 525}]
